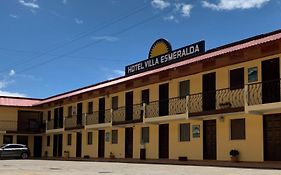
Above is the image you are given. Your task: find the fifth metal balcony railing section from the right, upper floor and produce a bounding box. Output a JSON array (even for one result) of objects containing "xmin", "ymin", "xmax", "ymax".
[{"xmin": 86, "ymin": 109, "xmax": 112, "ymax": 125}]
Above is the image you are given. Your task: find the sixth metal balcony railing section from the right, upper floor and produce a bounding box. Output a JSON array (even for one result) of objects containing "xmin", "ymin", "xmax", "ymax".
[{"xmin": 65, "ymin": 114, "xmax": 85, "ymax": 129}]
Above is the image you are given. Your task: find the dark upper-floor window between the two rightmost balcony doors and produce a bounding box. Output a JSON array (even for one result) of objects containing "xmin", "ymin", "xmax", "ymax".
[{"xmin": 230, "ymin": 68, "xmax": 244, "ymax": 89}]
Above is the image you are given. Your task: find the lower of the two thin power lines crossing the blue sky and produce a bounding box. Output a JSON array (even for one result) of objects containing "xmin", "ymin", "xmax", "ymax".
[{"xmin": 15, "ymin": 10, "xmax": 172, "ymax": 73}]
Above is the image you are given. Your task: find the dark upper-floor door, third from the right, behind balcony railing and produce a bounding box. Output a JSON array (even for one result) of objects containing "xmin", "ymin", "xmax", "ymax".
[{"xmin": 159, "ymin": 83, "xmax": 169, "ymax": 116}]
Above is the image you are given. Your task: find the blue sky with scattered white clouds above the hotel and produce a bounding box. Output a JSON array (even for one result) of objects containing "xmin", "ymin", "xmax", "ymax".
[{"xmin": 0, "ymin": 0, "xmax": 281, "ymax": 98}]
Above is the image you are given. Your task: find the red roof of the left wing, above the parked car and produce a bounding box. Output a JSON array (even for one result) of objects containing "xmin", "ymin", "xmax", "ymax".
[{"xmin": 0, "ymin": 96, "xmax": 41, "ymax": 107}]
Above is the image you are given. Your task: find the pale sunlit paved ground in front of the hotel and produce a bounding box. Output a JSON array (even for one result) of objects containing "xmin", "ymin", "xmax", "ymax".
[{"xmin": 0, "ymin": 160, "xmax": 281, "ymax": 175}]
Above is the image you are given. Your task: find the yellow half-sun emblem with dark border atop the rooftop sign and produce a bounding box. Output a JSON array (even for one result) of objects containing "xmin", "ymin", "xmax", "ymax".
[{"xmin": 148, "ymin": 38, "xmax": 172, "ymax": 58}]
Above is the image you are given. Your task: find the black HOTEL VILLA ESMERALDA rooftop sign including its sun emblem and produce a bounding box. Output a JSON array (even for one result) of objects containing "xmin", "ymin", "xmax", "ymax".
[{"xmin": 125, "ymin": 39, "xmax": 205, "ymax": 75}]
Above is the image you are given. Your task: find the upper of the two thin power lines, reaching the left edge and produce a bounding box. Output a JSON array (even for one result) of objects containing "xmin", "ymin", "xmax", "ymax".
[{"xmin": 0, "ymin": 4, "xmax": 148, "ymax": 72}]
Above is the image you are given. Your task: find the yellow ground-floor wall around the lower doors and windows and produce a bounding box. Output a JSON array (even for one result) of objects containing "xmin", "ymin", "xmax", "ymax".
[{"xmin": 38, "ymin": 113, "xmax": 270, "ymax": 161}]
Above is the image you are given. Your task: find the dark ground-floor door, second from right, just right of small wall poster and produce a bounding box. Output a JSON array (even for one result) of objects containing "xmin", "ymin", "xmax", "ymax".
[{"xmin": 203, "ymin": 120, "xmax": 217, "ymax": 160}]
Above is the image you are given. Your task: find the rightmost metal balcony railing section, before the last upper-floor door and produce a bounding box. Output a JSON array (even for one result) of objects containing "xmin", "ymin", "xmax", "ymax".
[{"xmin": 247, "ymin": 80, "xmax": 280, "ymax": 106}]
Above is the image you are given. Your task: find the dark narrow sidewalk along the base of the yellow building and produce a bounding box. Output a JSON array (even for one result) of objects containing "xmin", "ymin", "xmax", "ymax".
[{"xmin": 37, "ymin": 158, "xmax": 281, "ymax": 170}]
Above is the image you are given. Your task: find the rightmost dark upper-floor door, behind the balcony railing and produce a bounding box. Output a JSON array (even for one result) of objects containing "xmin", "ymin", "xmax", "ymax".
[{"xmin": 262, "ymin": 58, "xmax": 280, "ymax": 103}]
